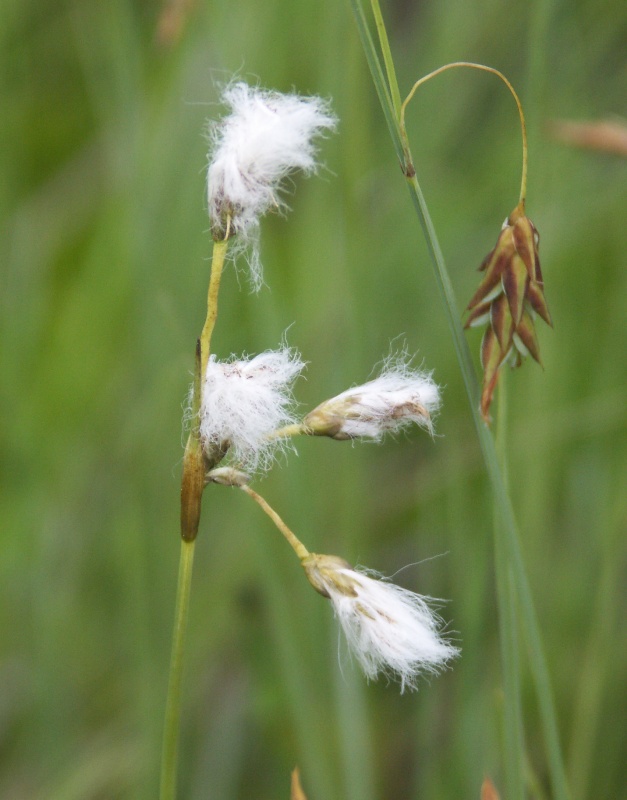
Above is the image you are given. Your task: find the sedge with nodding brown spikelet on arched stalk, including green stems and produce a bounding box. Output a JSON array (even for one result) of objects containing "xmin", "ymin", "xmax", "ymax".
[{"xmin": 351, "ymin": 0, "xmax": 569, "ymax": 800}]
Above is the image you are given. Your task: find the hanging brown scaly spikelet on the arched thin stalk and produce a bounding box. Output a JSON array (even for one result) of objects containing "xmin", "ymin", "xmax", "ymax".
[{"xmin": 464, "ymin": 201, "xmax": 553, "ymax": 422}]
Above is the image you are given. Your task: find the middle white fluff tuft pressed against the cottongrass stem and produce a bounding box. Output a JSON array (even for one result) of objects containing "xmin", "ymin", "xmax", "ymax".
[{"xmin": 200, "ymin": 347, "xmax": 305, "ymax": 471}]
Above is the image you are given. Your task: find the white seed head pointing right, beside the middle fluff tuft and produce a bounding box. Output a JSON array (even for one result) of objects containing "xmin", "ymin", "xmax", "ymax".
[{"xmin": 303, "ymin": 353, "xmax": 440, "ymax": 440}]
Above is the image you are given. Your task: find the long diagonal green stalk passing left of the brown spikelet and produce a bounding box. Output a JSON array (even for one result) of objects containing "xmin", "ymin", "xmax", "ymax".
[{"xmin": 351, "ymin": 0, "xmax": 569, "ymax": 800}]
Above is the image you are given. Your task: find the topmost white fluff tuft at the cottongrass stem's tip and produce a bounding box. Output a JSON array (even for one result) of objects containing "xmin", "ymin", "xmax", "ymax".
[{"xmin": 207, "ymin": 82, "xmax": 336, "ymax": 289}]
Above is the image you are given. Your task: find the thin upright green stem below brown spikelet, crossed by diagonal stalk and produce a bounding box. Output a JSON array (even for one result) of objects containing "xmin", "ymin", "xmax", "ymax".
[{"xmin": 494, "ymin": 375, "xmax": 525, "ymax": 800}]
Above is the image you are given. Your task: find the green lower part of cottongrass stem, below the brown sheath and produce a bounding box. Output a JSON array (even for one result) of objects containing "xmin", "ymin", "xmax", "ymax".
[{"xmin": 159, "ymin": 540, "xmax": 196, "ymax": 800}]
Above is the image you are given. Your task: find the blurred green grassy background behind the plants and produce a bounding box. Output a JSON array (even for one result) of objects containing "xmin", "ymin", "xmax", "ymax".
[{"xmin": 0, "ymin": 0, "xmax": 627, "ymax": 800}]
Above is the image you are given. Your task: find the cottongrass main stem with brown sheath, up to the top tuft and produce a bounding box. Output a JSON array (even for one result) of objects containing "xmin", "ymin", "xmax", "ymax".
[{"xmin": 159, "ymin": 231, "xmax": 229, "ymax": 800}]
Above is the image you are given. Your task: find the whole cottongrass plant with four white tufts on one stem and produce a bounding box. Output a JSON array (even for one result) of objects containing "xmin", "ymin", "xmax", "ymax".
[{"xmin": 161, "ymin": 82, "xmax": 458, "ymax": 800}]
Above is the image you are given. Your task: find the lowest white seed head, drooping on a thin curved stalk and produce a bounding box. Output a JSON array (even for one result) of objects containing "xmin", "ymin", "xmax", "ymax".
[{"xmin": 303, "ymin": 554, "xmax": 459, "ymax": 692}]
